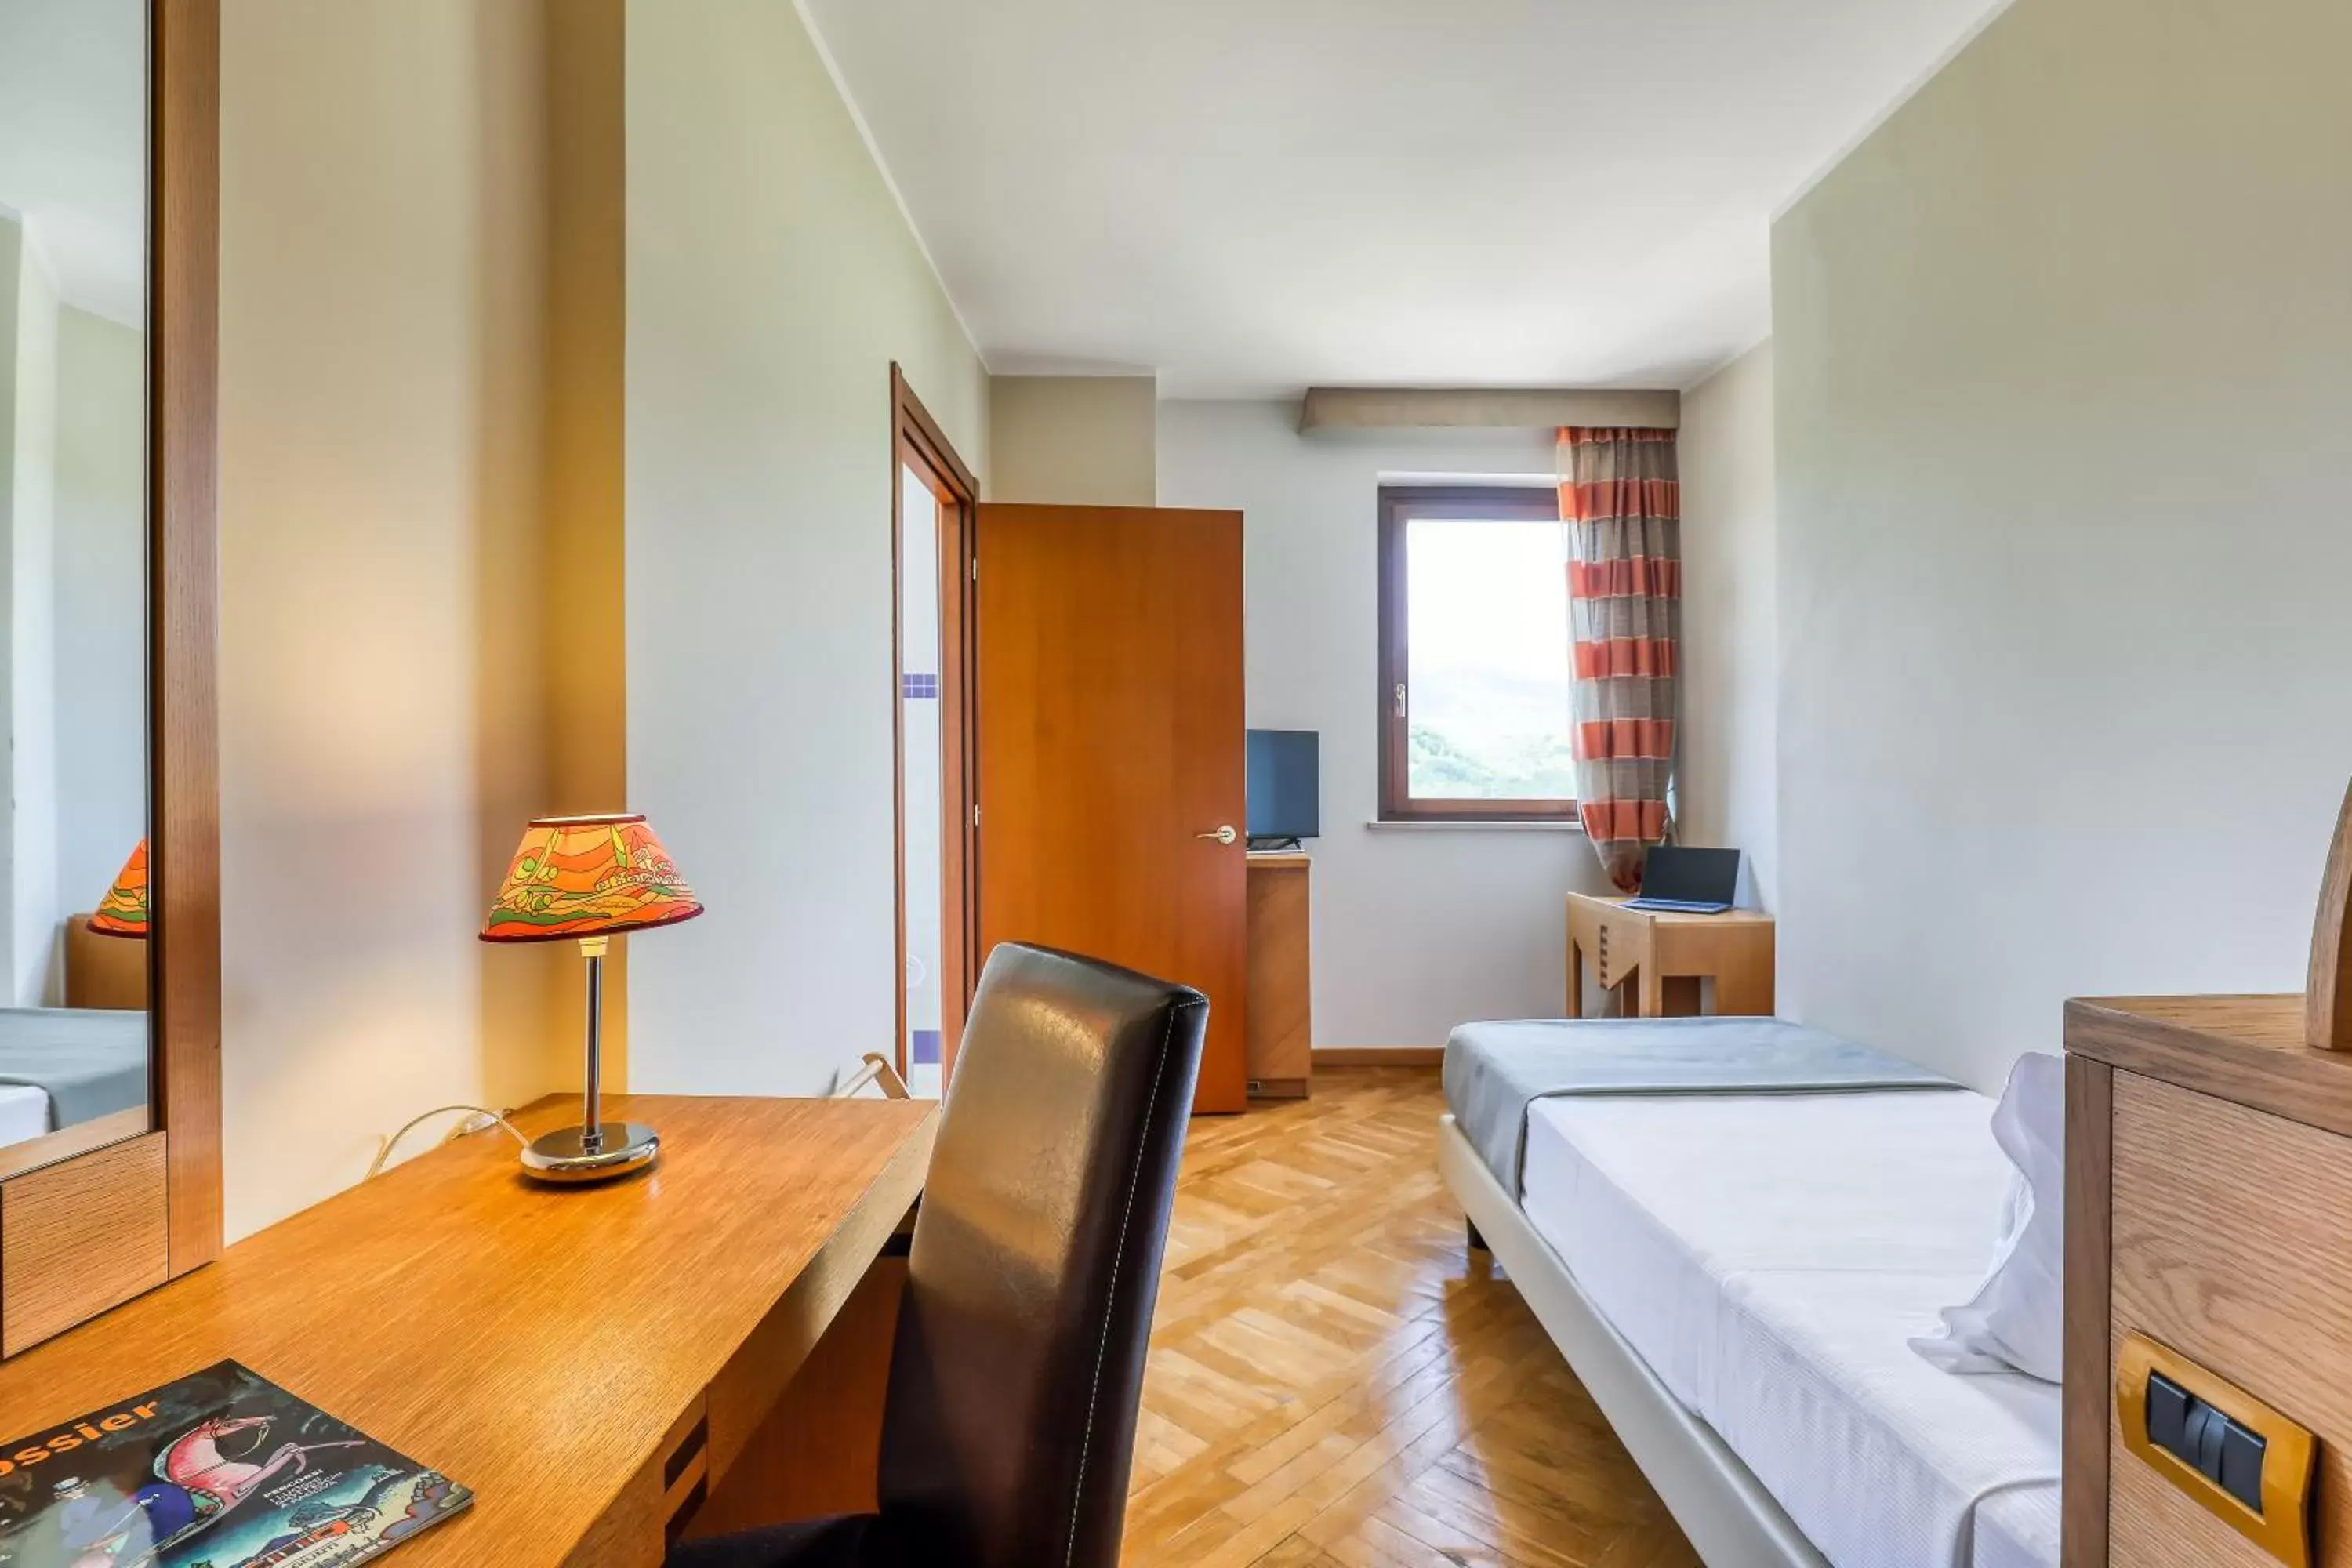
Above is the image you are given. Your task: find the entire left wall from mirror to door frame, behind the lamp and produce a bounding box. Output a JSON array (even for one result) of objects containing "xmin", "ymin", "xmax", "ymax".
[{"xmin": 221, "ymin": 0, "xmax": 964, "ymax": 1234}]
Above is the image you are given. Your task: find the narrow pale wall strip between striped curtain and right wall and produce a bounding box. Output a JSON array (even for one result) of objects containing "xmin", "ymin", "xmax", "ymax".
[{"xmin": 1675, "ymin": 343, "xmax": 1780, "ymax": 909}]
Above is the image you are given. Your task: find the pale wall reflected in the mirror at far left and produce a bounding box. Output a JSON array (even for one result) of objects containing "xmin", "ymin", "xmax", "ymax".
[{"xmin": 56, "ymin": 306, "xmax": 148, "ymax": 914}]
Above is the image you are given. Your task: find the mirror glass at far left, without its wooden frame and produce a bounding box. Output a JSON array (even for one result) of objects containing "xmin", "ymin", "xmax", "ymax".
[{"xmin": 0, "ymin": 0, "xmax": 155, "ymax": 1171}]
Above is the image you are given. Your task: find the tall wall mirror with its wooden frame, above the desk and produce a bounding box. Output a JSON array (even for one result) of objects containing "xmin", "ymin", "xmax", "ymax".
[{"xmin": 0, "ymin": 0, "xmax": 221, "ymax": 1356}]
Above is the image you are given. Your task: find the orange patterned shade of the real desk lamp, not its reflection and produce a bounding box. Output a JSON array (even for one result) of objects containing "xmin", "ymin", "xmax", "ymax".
[{"xmin": 482, "ymin": 815, "xmax": 703, "ymax": 942}]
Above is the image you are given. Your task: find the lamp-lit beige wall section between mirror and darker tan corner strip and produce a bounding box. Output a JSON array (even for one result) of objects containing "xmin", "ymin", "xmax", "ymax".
[{"xmin": 221, "ymin": 0, "xmax": 619, "ymax": 1236}]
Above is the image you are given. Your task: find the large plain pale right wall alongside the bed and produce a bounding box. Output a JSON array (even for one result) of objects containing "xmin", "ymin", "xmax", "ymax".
[{"xmin": 1773, "ymin": 0, "xmax": 2352, "ymax": 1086}]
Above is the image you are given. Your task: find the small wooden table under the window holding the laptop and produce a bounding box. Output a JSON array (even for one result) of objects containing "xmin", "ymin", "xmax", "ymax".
[{"xmin": 1569, "ymin": 893, "xmax": 1773, "ymax": 1018}]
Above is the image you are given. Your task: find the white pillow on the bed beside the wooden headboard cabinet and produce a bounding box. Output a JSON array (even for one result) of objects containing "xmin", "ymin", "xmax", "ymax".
[{"xmin": 1910, "ymin": 1055, "xmax": 2065, "ymax": 1382}]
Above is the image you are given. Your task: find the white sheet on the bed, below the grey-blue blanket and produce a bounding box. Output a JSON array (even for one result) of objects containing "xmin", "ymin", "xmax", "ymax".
[{"xmin": 1522, "ymin": 1093, "xmax": 2058, "ymax": 1568}]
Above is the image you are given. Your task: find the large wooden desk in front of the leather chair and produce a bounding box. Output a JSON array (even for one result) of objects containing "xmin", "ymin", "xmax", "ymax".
[{"xmin": 0, "ymin": 1095, "xmax": 938, "ymax": 1568}]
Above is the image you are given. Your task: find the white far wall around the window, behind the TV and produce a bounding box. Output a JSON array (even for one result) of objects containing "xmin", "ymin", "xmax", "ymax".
[{"xmin": 1160, "ymin": 402, "xmax": 1606, "ymax": 1046}]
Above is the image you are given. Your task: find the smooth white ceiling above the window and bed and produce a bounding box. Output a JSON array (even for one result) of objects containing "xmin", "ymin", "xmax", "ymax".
[{"xmin": 802, "ymin": 0, "xmax": 2006, "ymax": 397}]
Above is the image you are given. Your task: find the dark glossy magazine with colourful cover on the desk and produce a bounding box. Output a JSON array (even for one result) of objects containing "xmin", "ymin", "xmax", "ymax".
[{"xmin": 0, "ymin": 1361, "xmax": 473, "ymax": 1568}]
